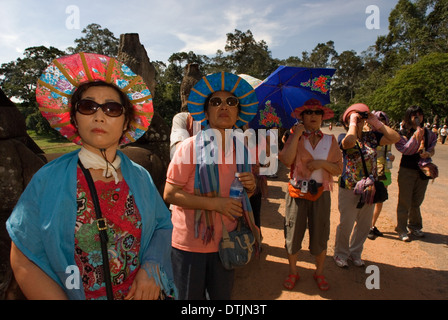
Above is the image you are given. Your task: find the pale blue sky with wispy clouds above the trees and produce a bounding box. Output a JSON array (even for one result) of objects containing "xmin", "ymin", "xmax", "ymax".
[{"xmin": 0, "ymin": 0, "xmax": 398, "ymax": 65}]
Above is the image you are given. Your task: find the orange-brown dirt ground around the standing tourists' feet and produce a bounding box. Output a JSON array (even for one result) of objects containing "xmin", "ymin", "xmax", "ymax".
[{"xmin": 233, "ymin": 128, "xmax": 448, "ymax": 300}]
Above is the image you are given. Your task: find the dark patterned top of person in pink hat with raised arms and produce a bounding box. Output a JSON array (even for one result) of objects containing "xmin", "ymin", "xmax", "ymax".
[{"xmin": 338, "ymin": 131, "xmax": 382, "ymax": 190}]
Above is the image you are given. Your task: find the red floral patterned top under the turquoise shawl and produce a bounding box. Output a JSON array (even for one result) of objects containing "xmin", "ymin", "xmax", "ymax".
[{"xmin": 75, "ymin": 169, "xmax": 141, "ymax": 300}]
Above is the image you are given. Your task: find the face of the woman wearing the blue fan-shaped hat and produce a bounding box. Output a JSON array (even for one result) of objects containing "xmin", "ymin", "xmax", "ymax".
[{"xmin": 205, "ymin": 91, "xmax": 238, "ymax": 129}]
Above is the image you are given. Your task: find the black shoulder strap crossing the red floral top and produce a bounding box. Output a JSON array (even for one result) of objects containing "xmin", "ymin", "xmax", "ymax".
[{"xmin": 78, "ymin": 160, "xmax": 114, "ymax": 300}]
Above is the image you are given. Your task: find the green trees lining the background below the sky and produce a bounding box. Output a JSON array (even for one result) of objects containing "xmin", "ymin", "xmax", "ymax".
[{"xmin": 0, "ymin": 0, "xmax": 448, "ymax": 132}]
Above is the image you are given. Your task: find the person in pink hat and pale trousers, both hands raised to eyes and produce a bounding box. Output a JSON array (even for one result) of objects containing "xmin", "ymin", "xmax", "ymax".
[{"xmin": 333, "ymin": 103, "xmax": 400, "ymax": 268}]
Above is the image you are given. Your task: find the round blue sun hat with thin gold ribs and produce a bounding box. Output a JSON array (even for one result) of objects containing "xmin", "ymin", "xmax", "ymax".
[{"xmin": 187, "ymin": 72, "xmax": 258, "ymax": 127}]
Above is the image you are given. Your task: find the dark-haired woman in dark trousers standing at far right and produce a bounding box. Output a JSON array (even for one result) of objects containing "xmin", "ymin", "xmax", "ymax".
[{"xmin": 395, "ymin": 106, "xmax": 437, "ymax": 242}]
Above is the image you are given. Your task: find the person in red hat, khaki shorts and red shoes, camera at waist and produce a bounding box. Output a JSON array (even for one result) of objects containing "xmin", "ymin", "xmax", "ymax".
[{"xmin": 279, "ymin": 99, "xmax": 342, "ymax": 290}]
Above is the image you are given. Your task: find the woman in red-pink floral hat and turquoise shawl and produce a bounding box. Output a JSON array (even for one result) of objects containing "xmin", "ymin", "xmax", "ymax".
[{"xmin": 6, "ymin": 53, "xmax": 176, "ymax": 300}]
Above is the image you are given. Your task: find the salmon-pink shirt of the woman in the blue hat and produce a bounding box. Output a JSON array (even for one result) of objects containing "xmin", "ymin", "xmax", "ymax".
[{"xmin": 166, "ymin": 137, "xmax": 236, "ymax": 253}]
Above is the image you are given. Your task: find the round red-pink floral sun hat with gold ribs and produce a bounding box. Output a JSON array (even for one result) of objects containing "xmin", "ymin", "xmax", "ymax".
[{"xmin": 36, "ymin": 53, "xmax": 154, "ymax": 145}]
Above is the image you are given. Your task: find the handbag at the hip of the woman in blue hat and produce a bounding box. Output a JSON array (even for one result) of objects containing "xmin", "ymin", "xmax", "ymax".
[{"xmin": 219, "ymin": 216, "xmax": 255, "ymax": 270}]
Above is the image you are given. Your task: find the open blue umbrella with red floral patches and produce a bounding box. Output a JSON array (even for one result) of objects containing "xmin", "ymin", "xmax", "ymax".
[{"xmin": 249, "ymin": 66, "xmax": 336, "ymax": 129}]
